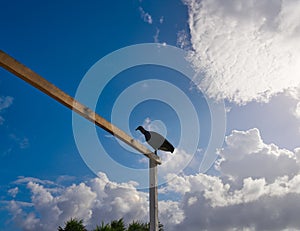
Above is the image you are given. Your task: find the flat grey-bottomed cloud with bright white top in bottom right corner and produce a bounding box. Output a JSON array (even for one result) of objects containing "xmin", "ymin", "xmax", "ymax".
[{"xmin": 174, "ymin": 175, "xmax": 300, "ymax": 231}]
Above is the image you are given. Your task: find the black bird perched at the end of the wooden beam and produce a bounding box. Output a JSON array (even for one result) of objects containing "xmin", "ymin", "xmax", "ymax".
[{"xmin": 135, "ymin": 126, "xmax": 174, "ymax": 153}]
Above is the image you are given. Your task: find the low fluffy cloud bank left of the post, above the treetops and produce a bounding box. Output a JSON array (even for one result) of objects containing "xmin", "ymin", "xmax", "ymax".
[{"xmin": 7, "ymin": 173, "xmax": 148, "ymax": 231}]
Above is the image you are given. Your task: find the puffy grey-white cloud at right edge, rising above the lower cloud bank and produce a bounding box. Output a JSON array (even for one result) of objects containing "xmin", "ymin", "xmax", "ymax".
[{"xmin": 217, "ymin": 128, "xmax": 300, "ymax": 182}]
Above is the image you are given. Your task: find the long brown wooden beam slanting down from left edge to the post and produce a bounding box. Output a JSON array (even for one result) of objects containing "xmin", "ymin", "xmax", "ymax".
[{"xmin": 0, "ymin": 50, "xmax": 161, "ymax": 164}]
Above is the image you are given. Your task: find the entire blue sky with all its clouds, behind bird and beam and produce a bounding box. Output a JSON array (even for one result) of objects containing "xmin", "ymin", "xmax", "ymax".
[{"xmin": 0, "ymin": 0, "xmax": 300, "ymax": 231}]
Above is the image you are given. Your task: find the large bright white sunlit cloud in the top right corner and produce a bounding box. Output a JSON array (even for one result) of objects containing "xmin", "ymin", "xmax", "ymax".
[{"xmin": 185, "ymin": 0, "xmax": 300, "ymax": 103}]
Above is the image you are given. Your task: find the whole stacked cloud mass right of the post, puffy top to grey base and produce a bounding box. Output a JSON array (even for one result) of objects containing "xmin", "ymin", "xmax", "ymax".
[{"xmin": 161, "ymin": 129, "xmax": 300, "ymax": 231}]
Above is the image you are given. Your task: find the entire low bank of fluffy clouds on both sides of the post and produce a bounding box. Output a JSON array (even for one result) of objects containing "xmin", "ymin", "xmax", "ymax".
[{"xmin": 6, "ymin": 128, "xmax": 300, "ymax": 231}]
